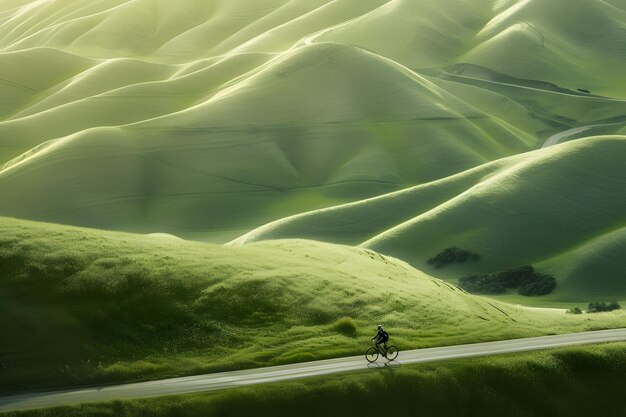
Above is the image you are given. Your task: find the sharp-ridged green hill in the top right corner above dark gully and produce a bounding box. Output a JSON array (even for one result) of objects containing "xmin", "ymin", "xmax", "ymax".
[{"xmin": 458, "ymin": 0, "xmax": 626, "ymax": 98}]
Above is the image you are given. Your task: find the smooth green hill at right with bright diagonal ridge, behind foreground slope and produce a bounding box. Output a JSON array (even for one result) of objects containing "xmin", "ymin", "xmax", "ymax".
[{"xmin": 233, "ymin": 136, "xmax": 626, "ymax": 301}]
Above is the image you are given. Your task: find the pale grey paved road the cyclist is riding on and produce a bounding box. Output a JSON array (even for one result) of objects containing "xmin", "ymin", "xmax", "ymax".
[{"xmin": 0, "ymin": 329, "xmax": 626, "ymax": 413}]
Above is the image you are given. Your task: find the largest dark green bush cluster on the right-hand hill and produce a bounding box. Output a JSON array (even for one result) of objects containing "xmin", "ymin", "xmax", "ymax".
[{"xmin": 459, "ymin": 265, "xmax": 556, "ymax": 296}]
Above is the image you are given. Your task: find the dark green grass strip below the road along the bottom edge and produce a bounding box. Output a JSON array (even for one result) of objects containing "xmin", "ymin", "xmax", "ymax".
[{"xmin": 6, "ymin": 343, "xmax": 626, "ymax": 417}]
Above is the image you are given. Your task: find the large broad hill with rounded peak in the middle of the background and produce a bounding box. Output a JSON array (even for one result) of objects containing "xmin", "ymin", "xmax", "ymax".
[{"xmin": 0, "ymin": 44, "xmax": 538, "ymax": 241}]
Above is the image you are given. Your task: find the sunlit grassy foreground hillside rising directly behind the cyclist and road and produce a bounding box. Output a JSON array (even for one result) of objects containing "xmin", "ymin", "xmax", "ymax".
[{"xmin": 0, "ymin": 214, "xmax": 624, "ymax": 393}]
